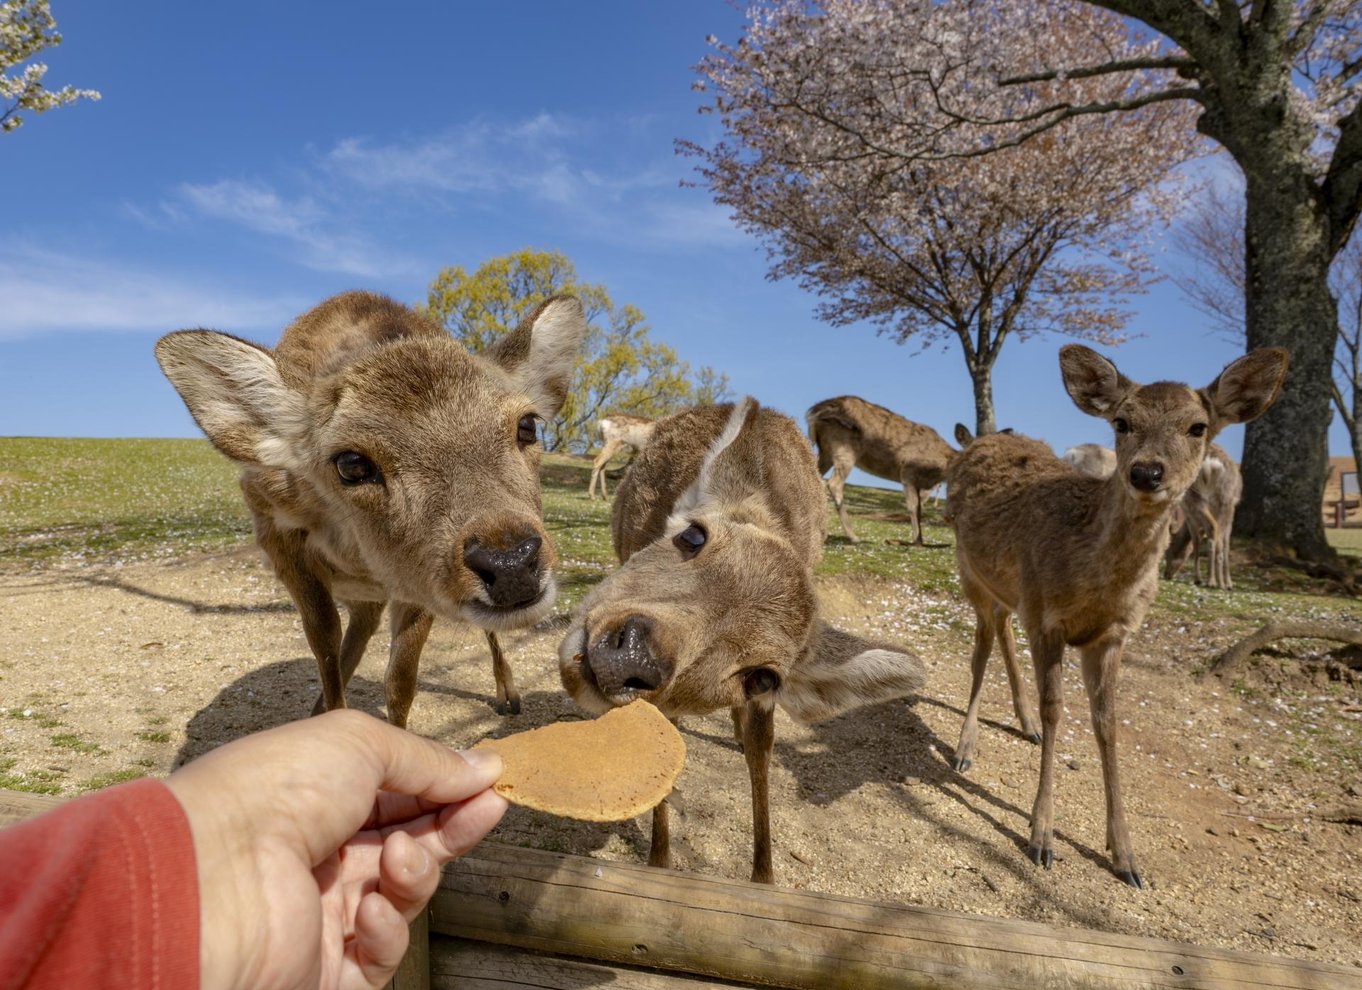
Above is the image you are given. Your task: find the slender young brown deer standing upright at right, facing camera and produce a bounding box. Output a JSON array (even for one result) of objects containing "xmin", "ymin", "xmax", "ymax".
[{"xmin": 947, "ymin": 345, "xmax": 1287, "ymax": 887}]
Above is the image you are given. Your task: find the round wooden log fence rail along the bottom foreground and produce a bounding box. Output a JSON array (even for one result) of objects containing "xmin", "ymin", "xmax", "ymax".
[{"xmin": 0, "ymin": 791, "xmax": 1362, "ymax": 990}]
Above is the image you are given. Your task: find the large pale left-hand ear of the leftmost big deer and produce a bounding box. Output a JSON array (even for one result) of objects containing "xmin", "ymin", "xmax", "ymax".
[{"xmin": 155, "ymin": 330, "xmax": 306, "ymax": 468}]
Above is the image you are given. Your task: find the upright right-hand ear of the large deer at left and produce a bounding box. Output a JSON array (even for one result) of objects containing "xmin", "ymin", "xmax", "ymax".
[{"xmin": 488, "ymin": 296, "xmax": 587, "ymax": 419}]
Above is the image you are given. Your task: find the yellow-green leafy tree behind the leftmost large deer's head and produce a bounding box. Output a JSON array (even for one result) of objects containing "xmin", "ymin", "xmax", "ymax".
[{"xmin": 424, "ymin": 248, "xmax": 729, "ymax": 452}]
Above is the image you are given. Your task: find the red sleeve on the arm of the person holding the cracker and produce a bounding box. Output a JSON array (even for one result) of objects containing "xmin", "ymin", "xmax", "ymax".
[{"xmin": 0, "ymin": 780, "xmax": 199, "ymax": 990}]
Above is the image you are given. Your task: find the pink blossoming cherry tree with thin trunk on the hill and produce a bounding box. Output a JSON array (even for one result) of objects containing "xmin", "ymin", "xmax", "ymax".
[{"xmin": 678, "ymin": 0, "xmax": 1197, "ymax": 433}]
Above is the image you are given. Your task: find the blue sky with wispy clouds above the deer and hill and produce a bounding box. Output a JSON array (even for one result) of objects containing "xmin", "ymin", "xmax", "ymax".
[{"xmin": 0, "ymin": 0, "xmax": 1348, "ymax": 468}]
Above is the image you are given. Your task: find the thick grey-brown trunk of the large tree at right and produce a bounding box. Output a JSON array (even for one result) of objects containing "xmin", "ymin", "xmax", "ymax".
[{"xmin": 1234, "ymin": 166, "xmax": 1339, "ymax": 561}]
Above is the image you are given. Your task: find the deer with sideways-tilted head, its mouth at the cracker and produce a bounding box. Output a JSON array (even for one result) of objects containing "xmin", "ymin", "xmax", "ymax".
[{"xmin": 558, "ymin": 398, "xmax": 925, "ymax": 884}]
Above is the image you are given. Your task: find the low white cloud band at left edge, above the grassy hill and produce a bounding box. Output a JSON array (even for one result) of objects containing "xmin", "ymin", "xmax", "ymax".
[{"xmin": 0, "ymin": 242, "xmax": 306, "ymax": 340}]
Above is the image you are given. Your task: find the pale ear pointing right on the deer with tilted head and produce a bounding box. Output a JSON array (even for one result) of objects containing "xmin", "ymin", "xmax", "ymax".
[{"xmin": 776, "ymin": 620, "xmax": 926, "ymax": 722}]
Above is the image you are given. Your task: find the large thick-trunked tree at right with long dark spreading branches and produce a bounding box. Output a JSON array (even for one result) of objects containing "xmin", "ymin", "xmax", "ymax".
[{"xmin": 860, "ymin": 0, "xmax": 1362, "ymax": 561}]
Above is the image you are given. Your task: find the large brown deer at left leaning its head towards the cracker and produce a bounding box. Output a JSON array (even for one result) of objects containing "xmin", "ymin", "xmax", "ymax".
[{"xmin": 157, "ymin": 293, "xmax": 586, "ymax": 726}]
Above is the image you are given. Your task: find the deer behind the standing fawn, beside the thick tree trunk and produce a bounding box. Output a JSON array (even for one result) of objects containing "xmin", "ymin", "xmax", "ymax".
[{"xmin": 1163, "ymin": 444, "xmax": 1244, "ymax": 590}]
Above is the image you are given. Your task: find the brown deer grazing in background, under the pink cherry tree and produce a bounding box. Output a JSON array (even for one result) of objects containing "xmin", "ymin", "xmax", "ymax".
[{"xmin": 804, "ymin": 395, "xmax": 956, "ymax": 545}]
